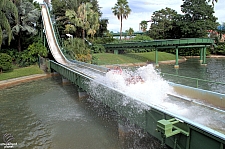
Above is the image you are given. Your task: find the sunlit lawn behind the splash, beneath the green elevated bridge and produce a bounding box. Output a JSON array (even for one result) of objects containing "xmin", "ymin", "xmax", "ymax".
[{"xmin": 94, "ymin": 52, "xmax": 178, "ymax": 65}]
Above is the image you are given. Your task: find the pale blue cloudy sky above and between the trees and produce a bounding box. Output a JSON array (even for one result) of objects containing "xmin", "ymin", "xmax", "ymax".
[{"xmin": 36, "ymin": 0, "xmax": 225, "ymax": 32}]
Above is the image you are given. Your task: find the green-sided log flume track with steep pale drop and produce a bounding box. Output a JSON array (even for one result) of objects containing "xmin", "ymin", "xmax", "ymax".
[{"xmin": 41, "ymin": 4, "xmax": 225, "ymax": 149}]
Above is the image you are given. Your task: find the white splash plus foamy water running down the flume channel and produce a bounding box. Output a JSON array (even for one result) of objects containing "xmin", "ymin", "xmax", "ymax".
[{"xmin": 88, "ymin": 64, "xmax": 225, "ymax": 134}]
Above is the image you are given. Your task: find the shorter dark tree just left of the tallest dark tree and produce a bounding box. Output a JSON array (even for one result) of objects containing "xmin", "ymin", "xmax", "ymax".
[{"xmin": 150, "ymin": 7, "xmax": 177, "ymax": 39}]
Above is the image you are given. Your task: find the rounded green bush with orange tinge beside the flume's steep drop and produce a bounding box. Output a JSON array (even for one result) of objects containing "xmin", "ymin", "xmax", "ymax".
[{"xmin": 64, "ymin": 38, "xmax": 92, "ymax": 63}]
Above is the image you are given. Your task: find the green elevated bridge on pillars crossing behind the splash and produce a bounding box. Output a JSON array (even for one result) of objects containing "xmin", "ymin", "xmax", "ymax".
[{"xmin": 104, "ymin": 38, "xmax": 214, "ymax": 67}]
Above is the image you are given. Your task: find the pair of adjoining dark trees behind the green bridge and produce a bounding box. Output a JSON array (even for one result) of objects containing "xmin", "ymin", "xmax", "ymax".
[{"xmin": 149, "ymin": 0, "xmax": 218, "ymax": 39}]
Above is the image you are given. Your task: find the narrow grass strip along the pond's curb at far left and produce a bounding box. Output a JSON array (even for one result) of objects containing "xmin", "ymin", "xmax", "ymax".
[{"xmin": 0, "ymin": 65, "xmax": 44, "ymax": 81}]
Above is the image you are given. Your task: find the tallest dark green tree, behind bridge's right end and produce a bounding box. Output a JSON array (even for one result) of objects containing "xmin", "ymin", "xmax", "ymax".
[{"xmin": 180, "ymin": 0, "xmax": 218, "ymax": 38}]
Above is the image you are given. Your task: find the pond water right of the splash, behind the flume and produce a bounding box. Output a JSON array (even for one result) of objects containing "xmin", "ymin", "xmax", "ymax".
[{"xmin": 158, "ymin": 58, "xmax": 225, "ymax": 93}]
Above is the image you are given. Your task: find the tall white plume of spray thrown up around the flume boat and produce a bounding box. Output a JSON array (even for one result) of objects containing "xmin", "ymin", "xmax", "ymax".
[{"xmin": 93, "ymin": 64, "xmax": 172, "ymax": 105}]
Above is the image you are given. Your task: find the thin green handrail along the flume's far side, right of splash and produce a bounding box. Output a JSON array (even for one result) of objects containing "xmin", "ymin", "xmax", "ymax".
[{"xmin": 161, "ymin": 73, "xmax": 225, "ymax": 88}]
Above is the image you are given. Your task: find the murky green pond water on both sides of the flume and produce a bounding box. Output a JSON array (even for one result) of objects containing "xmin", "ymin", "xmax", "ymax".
[{"xmin": 0, "ymin": 59, "xmax": 225, "ymax": 149}]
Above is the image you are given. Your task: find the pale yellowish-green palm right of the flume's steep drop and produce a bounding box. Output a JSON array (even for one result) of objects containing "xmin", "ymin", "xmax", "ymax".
[{"xmin": 66, "ymin": 3, "xmax": 99, "ymax": 39}]
